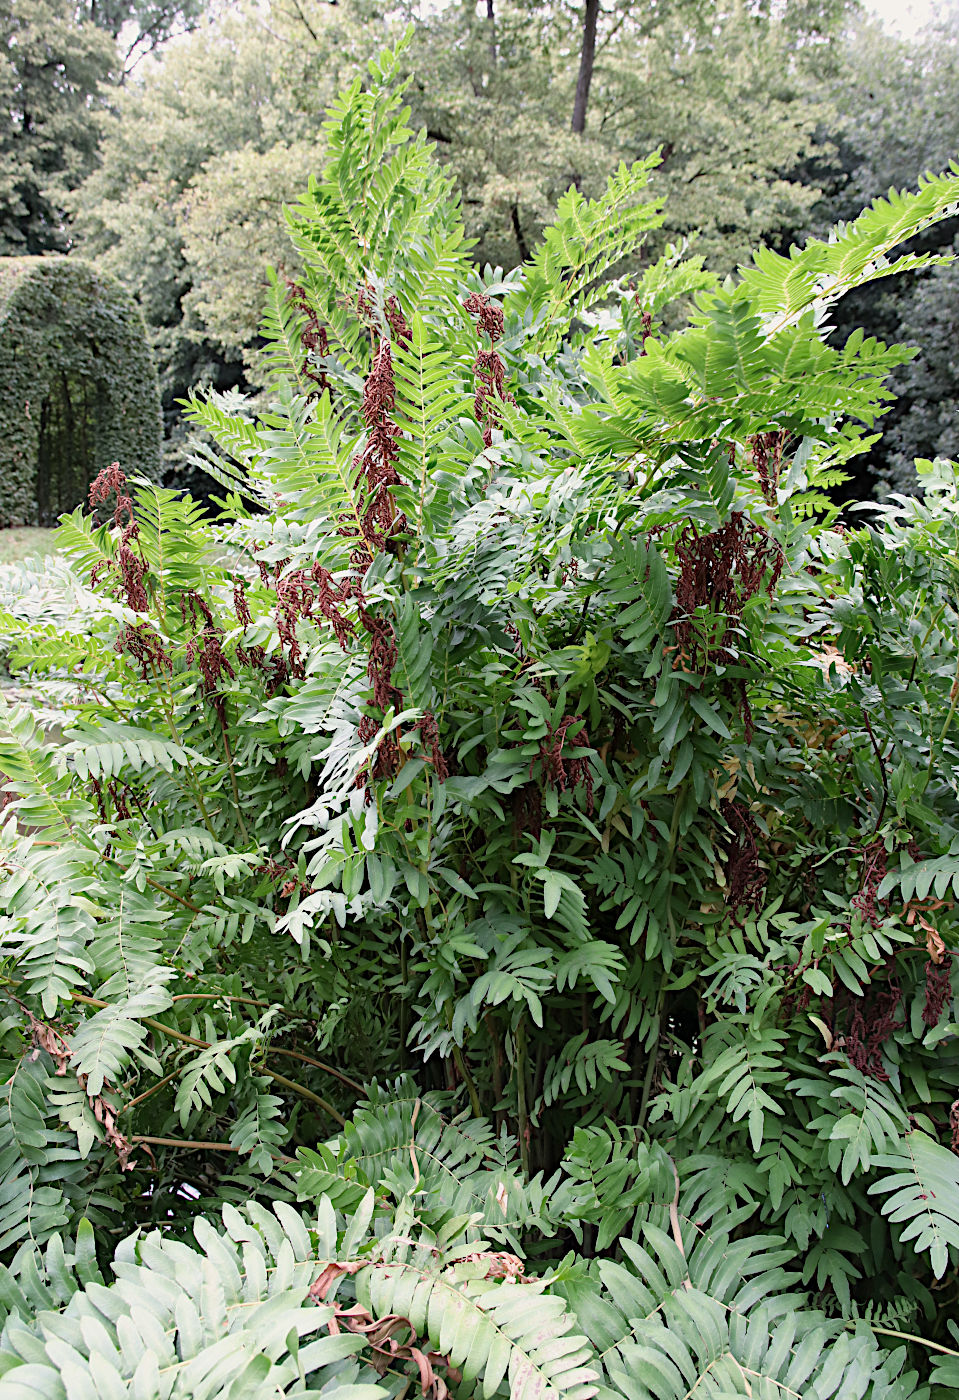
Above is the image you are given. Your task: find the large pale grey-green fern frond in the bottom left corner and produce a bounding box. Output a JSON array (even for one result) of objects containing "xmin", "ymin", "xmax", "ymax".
[{"xmin": 0, "ymin": 1201, "xmax": 389, "ymax": 1400}]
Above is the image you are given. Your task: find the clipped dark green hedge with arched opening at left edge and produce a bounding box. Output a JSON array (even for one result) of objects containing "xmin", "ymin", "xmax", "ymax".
[{"xmin": 0, "ymin": 258, "xmax": 162, "ymax": 526}]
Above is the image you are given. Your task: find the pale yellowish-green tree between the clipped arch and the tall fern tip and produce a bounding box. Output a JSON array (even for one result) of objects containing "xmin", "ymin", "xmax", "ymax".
[{"xmin": 73, "ymin": 1, "xmax": 366, "ymax": 470}]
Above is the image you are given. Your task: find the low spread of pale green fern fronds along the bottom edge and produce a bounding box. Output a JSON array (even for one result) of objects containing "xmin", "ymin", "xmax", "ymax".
[{"xmin": 0, "ymin": 1110, "xmax": 916, "ymax": 1400}]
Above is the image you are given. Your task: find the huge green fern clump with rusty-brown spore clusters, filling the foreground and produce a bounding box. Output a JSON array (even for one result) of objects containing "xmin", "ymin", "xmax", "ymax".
[{"xmin": 0, "ymin": 35, "xmax": 959, "ymax": 1400}]
